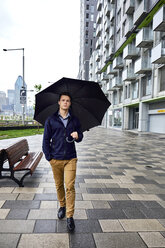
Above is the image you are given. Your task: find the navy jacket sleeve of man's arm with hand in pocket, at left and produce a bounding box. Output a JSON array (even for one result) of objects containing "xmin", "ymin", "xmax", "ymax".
[{"xmin": 42, "ymin": 118, "xmax": 52, "ymax": 161}]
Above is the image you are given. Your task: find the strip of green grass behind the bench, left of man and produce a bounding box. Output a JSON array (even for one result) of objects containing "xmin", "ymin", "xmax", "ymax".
[{"xmin": 0, "ymin": 128, "xmax": 44, "ymax": 140}]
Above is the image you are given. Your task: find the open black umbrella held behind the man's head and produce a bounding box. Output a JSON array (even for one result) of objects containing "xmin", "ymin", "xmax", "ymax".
[{"xmin": 34, "ymin": 77, "xmax": 110, "ymax": 131}]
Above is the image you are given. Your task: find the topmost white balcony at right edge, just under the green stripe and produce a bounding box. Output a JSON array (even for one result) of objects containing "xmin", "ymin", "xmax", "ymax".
[{"xmin": 153, "ymin": 5, "xmax": 165, "ymax": 32}]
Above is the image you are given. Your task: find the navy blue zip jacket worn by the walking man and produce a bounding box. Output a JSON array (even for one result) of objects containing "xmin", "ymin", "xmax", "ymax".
[{"xmin": 42, "ymin": 111, "xmax": 83, "ymax": 161}]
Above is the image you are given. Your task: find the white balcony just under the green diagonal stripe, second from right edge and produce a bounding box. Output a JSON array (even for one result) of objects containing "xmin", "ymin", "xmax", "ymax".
[{"xmin": 136, "ymin": 27, "xmax": 153, "ymax": 48}]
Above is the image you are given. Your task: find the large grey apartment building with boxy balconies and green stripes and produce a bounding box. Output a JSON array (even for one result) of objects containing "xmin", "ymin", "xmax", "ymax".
[{"xmin": 89, "ymin": 0, "xmax": 165, "ymax": 133}]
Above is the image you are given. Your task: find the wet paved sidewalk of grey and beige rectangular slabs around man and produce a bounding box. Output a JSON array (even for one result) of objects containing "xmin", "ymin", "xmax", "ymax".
[{"xmin": 0, "ymin": 128, "xmax": 165, "ymax": 248}]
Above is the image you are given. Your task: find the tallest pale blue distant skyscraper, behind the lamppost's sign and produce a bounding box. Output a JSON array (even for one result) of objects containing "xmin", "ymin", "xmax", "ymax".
[{"xmin": 14, "ymin": 76, "xmax": 27, "ymax": 114}]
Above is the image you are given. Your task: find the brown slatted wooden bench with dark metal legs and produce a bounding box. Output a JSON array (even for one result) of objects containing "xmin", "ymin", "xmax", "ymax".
[{"xmin": 0, "ymin": 139, "xmax": 43, "ymax": 187}]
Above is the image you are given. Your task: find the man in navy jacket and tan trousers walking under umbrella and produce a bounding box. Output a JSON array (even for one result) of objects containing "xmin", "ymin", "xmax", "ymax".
[{"xmin": 43, "ymin": 92, "xmax": 83, "ymax": 231}]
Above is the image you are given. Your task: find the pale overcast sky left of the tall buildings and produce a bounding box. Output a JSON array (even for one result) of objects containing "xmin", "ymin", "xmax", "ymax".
[{"xmin": 0, "ymin": 0, "xmax": 80, "ymax": 100}]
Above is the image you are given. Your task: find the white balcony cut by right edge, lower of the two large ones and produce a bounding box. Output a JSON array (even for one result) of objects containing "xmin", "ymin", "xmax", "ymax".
[{"xmin": 151, "ymin": 40, "xmax": 165, "ymax": 64}]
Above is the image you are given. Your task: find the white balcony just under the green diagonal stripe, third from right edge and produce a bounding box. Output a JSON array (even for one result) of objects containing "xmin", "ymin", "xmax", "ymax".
[{"xmin": 123, "ymin": 44, "xmax": 140, "ymax": 59}]
